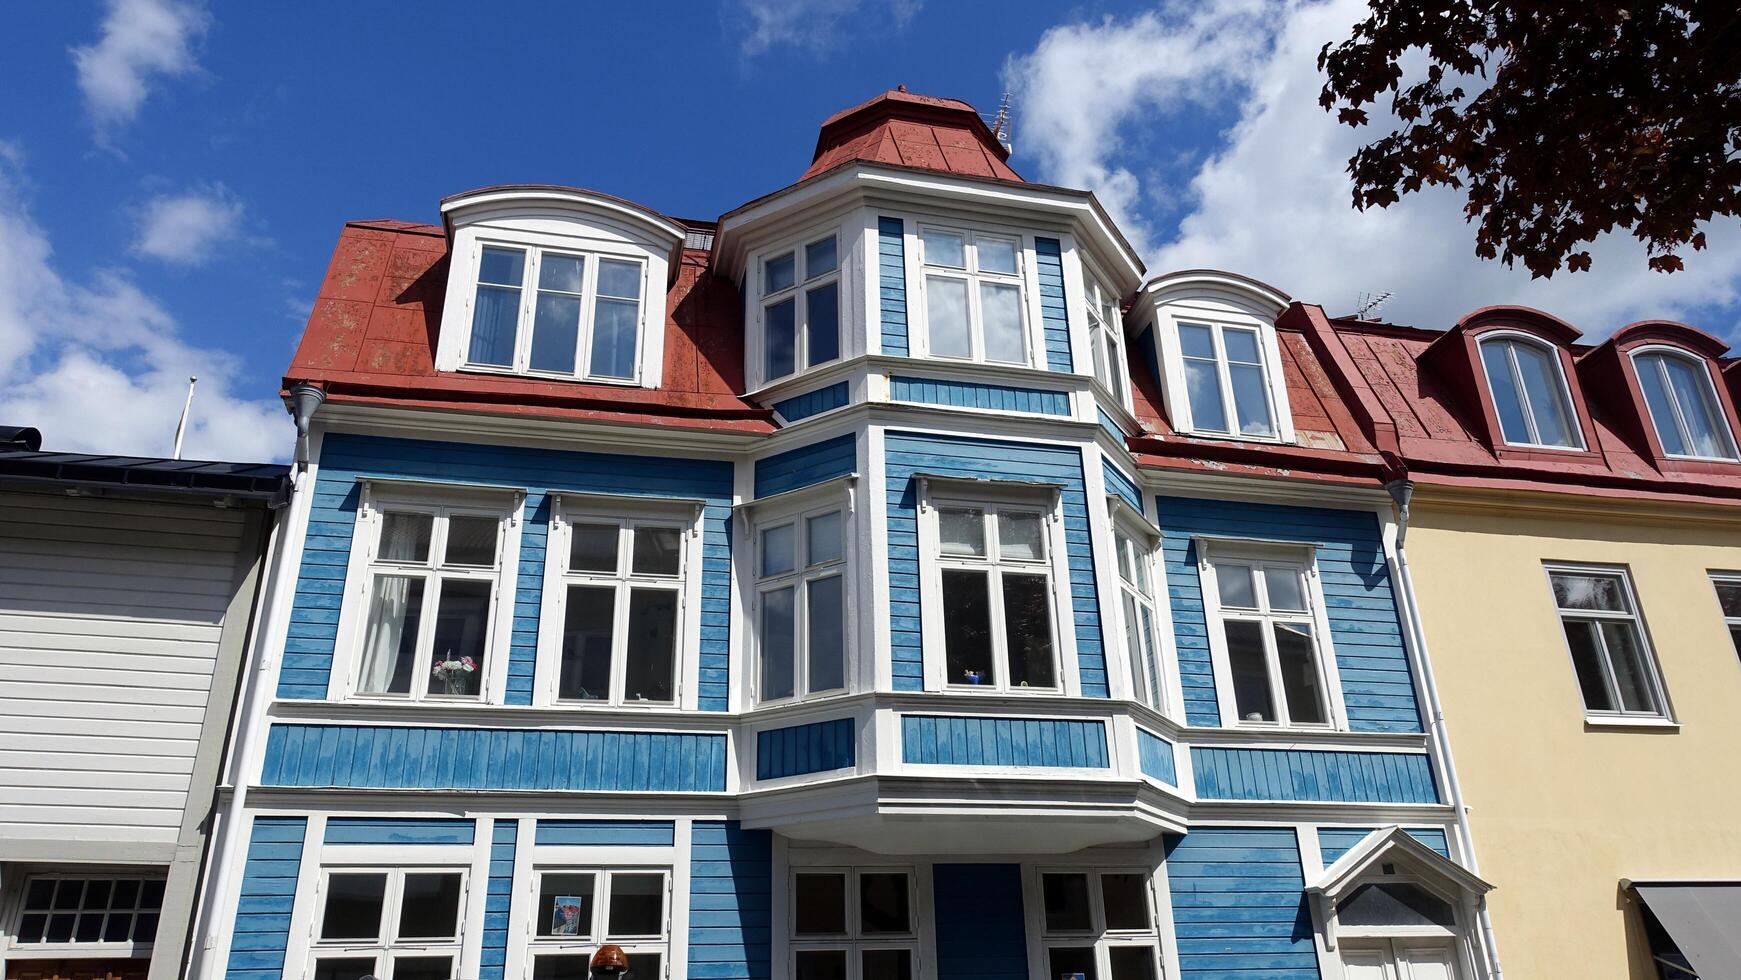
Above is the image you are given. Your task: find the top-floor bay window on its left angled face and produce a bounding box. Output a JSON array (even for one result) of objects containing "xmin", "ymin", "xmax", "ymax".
[{"xmin": 761, "ymin": 233, "xmax": 841, "ymax": 385}]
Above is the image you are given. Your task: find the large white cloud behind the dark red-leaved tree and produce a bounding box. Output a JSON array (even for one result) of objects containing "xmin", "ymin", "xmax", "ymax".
[{"xmin": 1006, "ymin": 0, "xmax": 1741, "ymax": 336}]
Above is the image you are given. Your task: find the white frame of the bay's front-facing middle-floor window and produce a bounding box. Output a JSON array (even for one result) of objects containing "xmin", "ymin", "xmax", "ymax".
[{"xmin": 919, "ymin": 479, "xmax": 1081, "ymax": 696}]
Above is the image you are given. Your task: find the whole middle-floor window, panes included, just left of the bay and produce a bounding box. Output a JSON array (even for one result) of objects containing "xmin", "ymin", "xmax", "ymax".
[{"xmin": 540, "ymin": 500, "xmax": 698, "ymax": 707}]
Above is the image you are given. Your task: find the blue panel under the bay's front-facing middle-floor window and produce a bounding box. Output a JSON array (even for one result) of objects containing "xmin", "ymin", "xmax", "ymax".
[{"xmin": 900, "ymin": 715, "xmax": 1111, "ymax": 769}]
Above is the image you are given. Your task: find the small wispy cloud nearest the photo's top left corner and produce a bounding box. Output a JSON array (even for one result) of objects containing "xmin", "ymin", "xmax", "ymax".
[{"xmin": 71, "ymin": 0, "xmax": 209, "ymax": 129}]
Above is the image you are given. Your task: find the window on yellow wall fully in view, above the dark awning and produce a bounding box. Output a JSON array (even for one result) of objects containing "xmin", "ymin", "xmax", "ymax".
[{"xmin": 1548, "ymin": 566, "xmax": 1668, "ymax": 719}]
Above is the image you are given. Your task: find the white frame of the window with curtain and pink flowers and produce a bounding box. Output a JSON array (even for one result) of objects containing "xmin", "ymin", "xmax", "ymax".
[{"xmin": 327, "ymin": 480, "xmax": 526, "ymax": 705}]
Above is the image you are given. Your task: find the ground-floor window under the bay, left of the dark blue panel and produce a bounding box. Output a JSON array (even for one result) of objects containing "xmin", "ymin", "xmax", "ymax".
[{"xmin": 789, "ymin": 867, "xmax": 919, "ymax": 980}]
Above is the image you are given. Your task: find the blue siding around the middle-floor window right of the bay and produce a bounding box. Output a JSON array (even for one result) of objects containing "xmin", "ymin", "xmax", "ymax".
[{"xmin": 1156, "ymin": 496, "xmax": 1421, "ymax": 731}]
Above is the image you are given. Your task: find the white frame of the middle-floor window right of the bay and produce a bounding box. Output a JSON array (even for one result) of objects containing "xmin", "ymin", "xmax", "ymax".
[{"xmin": 1196, "ymin": 538, "xmax": 1348, "ymax": 731}]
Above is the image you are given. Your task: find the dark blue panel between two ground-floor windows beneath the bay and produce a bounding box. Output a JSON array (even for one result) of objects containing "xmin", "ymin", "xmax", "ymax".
[{"xmin": 931, "ymin": 863, "xmax": 1027, "ymax": 980}]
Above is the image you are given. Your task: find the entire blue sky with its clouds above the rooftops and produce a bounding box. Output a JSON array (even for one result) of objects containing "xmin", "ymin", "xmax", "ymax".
[{"xmin": 0, "ymin": 0, "xmax": 1741, "ymax": 458}]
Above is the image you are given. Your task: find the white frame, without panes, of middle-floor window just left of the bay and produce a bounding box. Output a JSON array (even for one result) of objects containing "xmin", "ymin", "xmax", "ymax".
[{"xmin": 534, "ymin": 493, "xmax": 703, "ymax": 710}]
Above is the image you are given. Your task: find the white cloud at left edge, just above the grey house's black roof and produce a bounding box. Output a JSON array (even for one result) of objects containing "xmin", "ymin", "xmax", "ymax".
[{"xmin": 0, "ymin": 153, "xmax": 291, "ymax": 461}]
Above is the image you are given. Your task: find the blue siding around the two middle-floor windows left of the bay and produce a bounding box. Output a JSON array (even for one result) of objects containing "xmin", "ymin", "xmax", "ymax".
[{"xmin": 279, "ymin": 433, "xmax": 733, "ymax": 710}]
